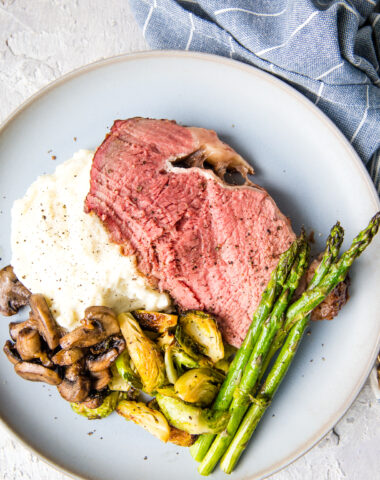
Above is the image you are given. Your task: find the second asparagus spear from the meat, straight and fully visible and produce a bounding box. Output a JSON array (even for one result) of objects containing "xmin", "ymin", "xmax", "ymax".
[{"xmin": 198, "ymin": 238, "xmax": 309, "ymax": 475}]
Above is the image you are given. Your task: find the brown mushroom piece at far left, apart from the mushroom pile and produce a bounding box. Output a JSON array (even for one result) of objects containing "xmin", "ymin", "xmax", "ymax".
[{"xmin": 0, "ymin": 265, "xmax": 30, "ymax": 317}]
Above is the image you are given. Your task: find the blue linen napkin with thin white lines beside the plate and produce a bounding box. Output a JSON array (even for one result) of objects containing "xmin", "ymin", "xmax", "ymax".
[{"xmin": 130, "ymin": 0, "xmax": 380, "ymax": 194}]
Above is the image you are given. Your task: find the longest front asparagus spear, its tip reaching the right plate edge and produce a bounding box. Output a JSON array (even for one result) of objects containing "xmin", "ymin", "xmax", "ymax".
[{"xmin": 220, "ymin": 212, "xmax": 380, "ymax": 473}]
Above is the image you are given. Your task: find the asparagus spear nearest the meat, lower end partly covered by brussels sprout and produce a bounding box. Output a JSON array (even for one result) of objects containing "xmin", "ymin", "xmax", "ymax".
[{"xmin": 190, "ymin": 236, "xmax": 298, "ymax": 462}]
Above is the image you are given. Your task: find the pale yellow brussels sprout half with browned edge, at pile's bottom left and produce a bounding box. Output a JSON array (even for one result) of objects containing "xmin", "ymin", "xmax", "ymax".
[{"xmin": 116, "ymin": 400, "xmax": 170, "ymax": 442}]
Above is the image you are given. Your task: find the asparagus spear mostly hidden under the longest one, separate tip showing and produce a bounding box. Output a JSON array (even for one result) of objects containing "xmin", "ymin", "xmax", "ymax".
[{"xmin": 260, "ymin": 222, "xmax": 344, "ymax": 380}]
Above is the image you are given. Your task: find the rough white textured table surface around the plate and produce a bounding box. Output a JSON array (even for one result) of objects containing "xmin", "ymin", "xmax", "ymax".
[{"xmin": 0, "ymin": 0, "xmax": 380, "ymax": 480}]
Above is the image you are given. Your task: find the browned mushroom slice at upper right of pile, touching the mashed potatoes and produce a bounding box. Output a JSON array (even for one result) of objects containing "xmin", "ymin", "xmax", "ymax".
[{"xmin": 60, "ymin": 307, "xmax": 120, "ymax": 350}]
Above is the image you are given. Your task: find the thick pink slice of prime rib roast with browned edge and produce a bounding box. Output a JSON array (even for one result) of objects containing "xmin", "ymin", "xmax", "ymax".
[{"xmin": 85, "ymin": 118, "xmax": 295, "ymax": 346}]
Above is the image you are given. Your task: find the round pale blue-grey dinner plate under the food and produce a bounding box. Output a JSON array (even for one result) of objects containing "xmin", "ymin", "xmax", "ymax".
[{"xmin": 0, "ymin": 52, "xmax": 380, "ymax": 480}]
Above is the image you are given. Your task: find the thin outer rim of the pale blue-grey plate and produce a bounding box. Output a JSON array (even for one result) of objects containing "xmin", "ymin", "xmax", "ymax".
[{"xmin": 0, "ymin": 50, "xmax": 380, "ymax": 480}]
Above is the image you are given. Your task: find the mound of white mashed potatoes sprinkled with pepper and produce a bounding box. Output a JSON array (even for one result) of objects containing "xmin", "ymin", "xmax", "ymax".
[{"xmin": 11, "ymin": 150, "xmax": 170, "ymax": 329}]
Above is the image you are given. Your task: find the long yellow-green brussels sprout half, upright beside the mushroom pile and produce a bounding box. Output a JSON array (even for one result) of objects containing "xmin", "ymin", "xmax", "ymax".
[{"xmin": 116, "ymin": 313, "xmax": 166, "ymax": 393}]
